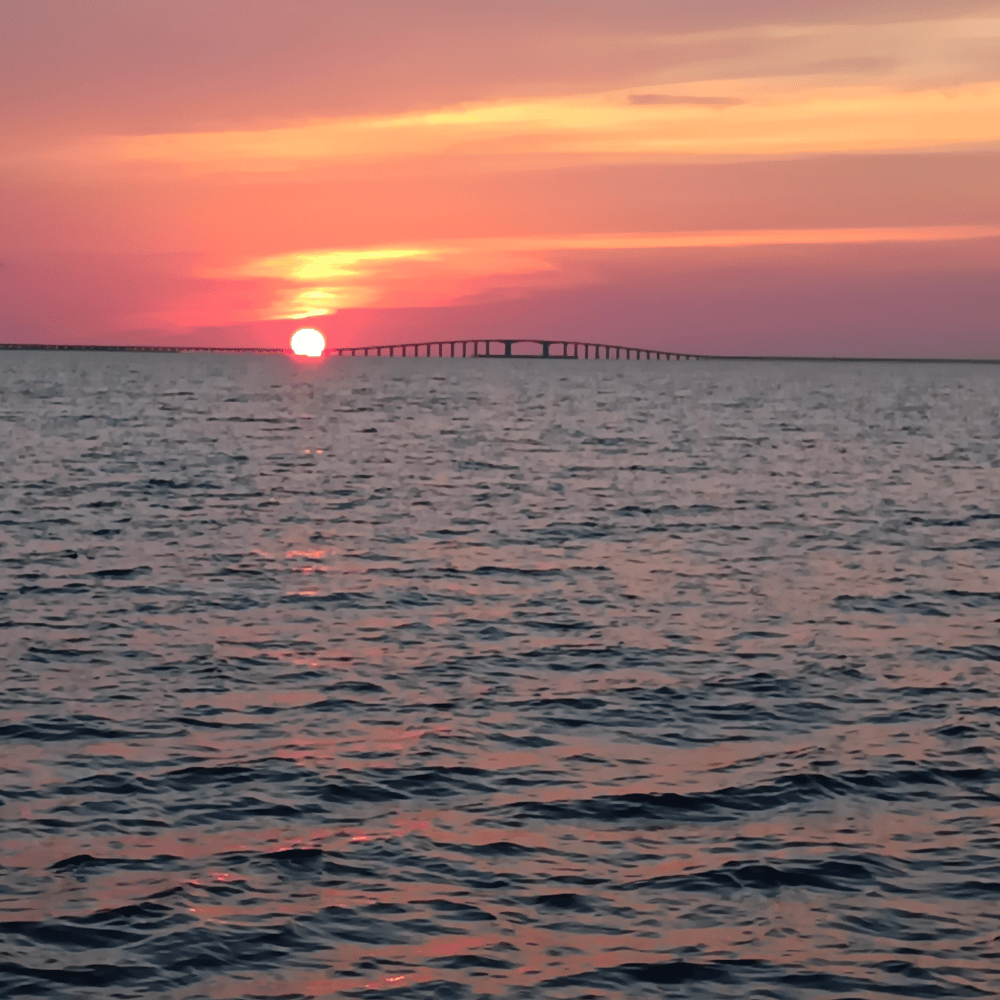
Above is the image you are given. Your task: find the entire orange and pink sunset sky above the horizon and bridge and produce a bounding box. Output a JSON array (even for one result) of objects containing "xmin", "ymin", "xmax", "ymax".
[{"xmin": 0, "ymin": 0, "xmax": 1000, "ymax": 358}]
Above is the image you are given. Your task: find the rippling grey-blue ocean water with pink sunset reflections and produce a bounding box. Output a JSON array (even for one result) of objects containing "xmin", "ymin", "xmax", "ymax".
[{"xmin": 0, "ymin": 352, "xmax": 1000, "ymax": 1000}]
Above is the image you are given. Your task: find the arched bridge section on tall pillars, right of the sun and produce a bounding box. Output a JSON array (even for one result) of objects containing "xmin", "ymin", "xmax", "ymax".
[{"xmin": 326, "ymin": 338, "xmax": 700, "ymax": 361}]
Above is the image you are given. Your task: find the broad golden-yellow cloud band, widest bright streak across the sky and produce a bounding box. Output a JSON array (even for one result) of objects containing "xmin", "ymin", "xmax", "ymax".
[{"xmin": 6, "ymin": 79, "xmax": 1000, "ymax": 181}]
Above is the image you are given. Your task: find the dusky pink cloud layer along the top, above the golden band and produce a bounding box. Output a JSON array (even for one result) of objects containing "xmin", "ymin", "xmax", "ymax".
[{"xmin": 0, "ymin": 0, "xmax": 995, "ymax": 134}]
